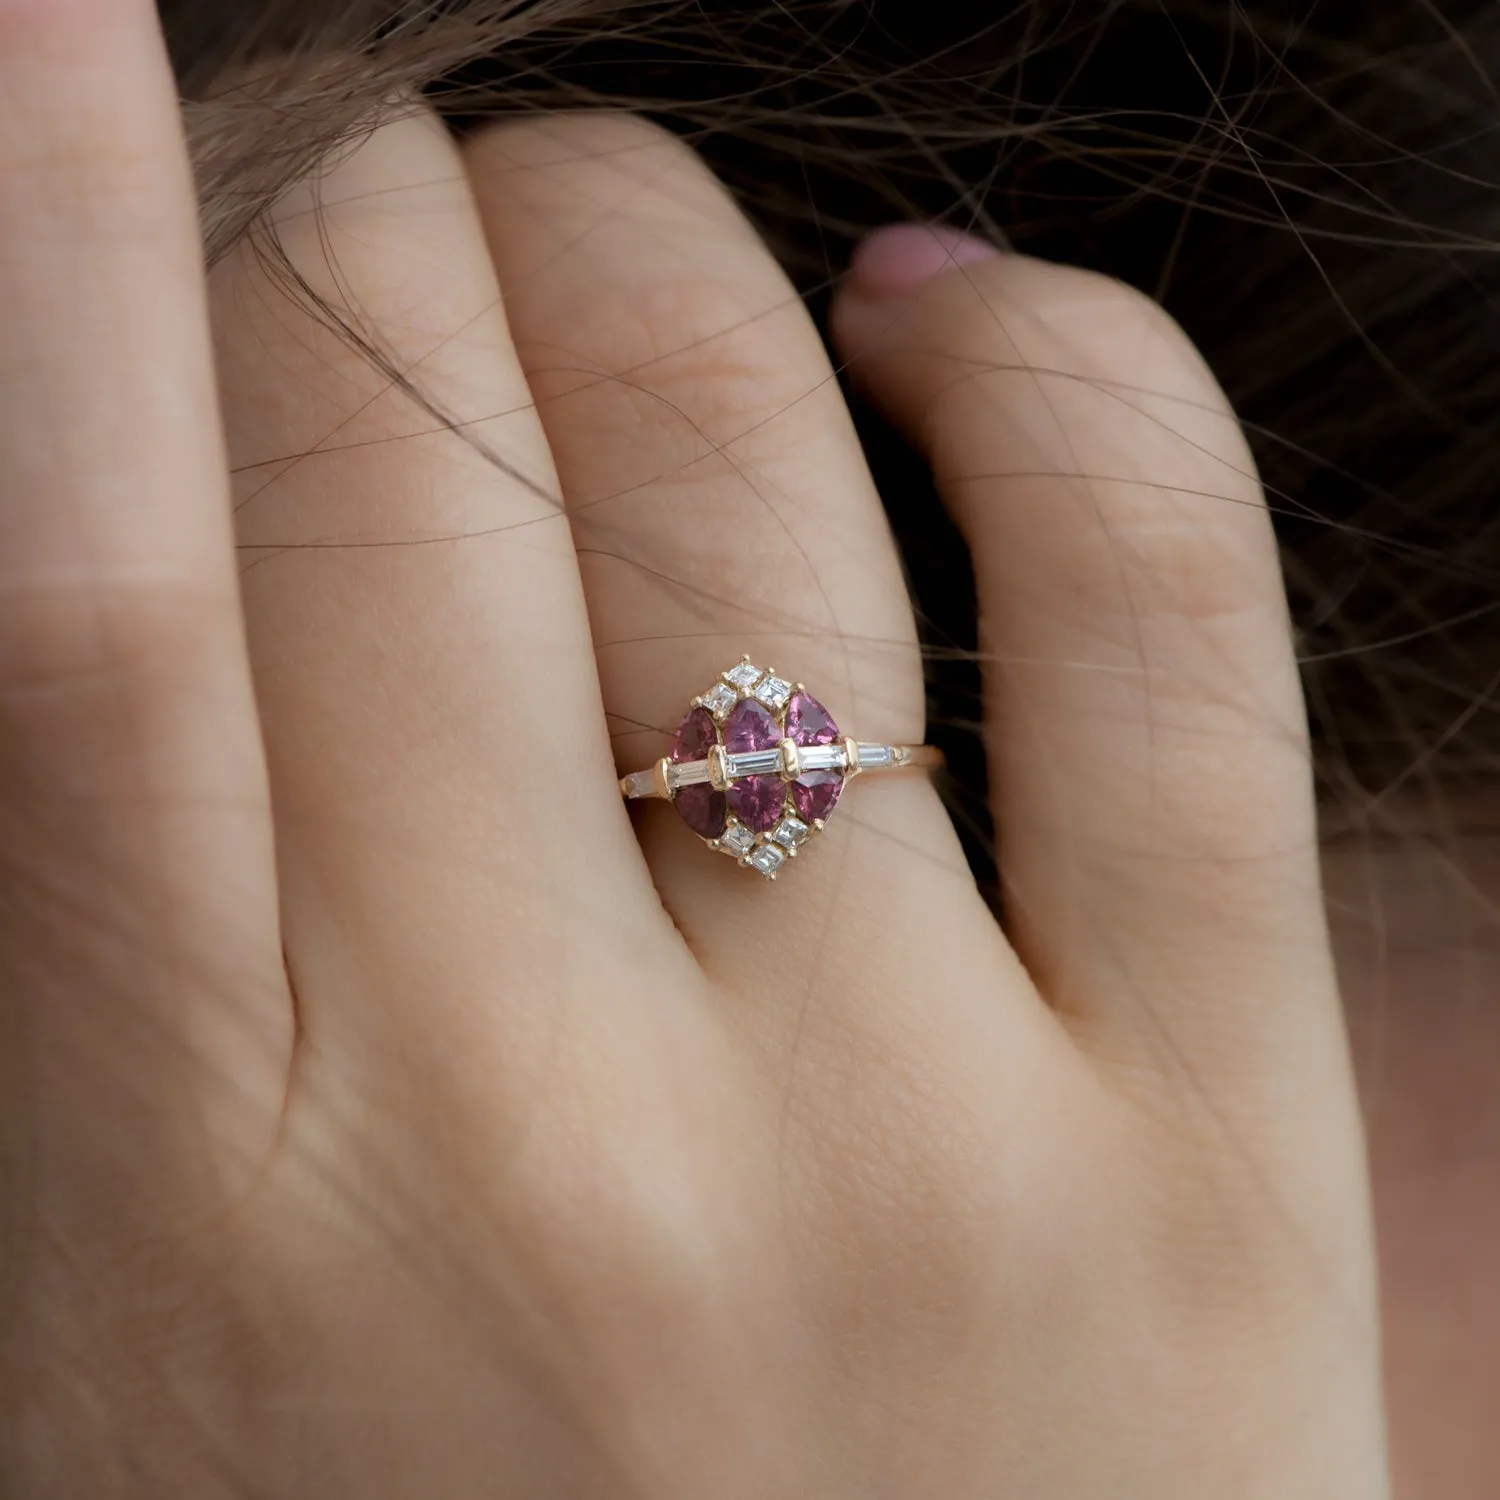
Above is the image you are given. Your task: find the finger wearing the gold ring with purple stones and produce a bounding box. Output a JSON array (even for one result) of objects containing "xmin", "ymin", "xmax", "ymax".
[{"xmin": 468, "ymin": 114, "xmax": 996, "ymax": 984}]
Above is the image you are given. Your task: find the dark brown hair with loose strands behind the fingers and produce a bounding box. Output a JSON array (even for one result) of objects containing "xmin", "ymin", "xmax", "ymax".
[{"xmin": 162, "ymin": 0, "xmax": 1500, "ymax": 878}]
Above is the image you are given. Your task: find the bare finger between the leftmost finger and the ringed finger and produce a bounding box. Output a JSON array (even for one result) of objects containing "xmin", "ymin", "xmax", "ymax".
[{"xmin": 212, "ymin": 102, "xmax": 669, "ymax": 1055}]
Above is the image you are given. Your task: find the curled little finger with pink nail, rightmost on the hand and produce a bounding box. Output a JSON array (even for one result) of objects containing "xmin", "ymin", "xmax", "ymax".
[{"xmin": 834, "ymin": 228, "xmax": 1335, "ymax": 1067}]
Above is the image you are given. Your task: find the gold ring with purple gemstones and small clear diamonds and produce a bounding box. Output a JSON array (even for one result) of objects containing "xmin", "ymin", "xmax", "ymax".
[{"xmin": 620, "ymin": 657, "xmax": 942, "ymax": 881}]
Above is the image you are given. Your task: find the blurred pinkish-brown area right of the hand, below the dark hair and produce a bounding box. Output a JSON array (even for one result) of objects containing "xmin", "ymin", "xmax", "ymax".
[{"xmin": 1325, "ymin": 822, "xmax": 1500, "ymax": 1500}]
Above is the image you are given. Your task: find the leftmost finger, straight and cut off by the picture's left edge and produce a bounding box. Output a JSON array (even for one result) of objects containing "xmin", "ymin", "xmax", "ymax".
[{"xmin": 0, "ymin": 0, "xmax": 291, "ymax": 1209}]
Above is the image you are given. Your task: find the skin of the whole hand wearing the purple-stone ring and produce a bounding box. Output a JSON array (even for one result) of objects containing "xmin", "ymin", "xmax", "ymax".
[{"xmin": 0, "ymin": 0, "xmax": 1386, "ymax": 1500}]
